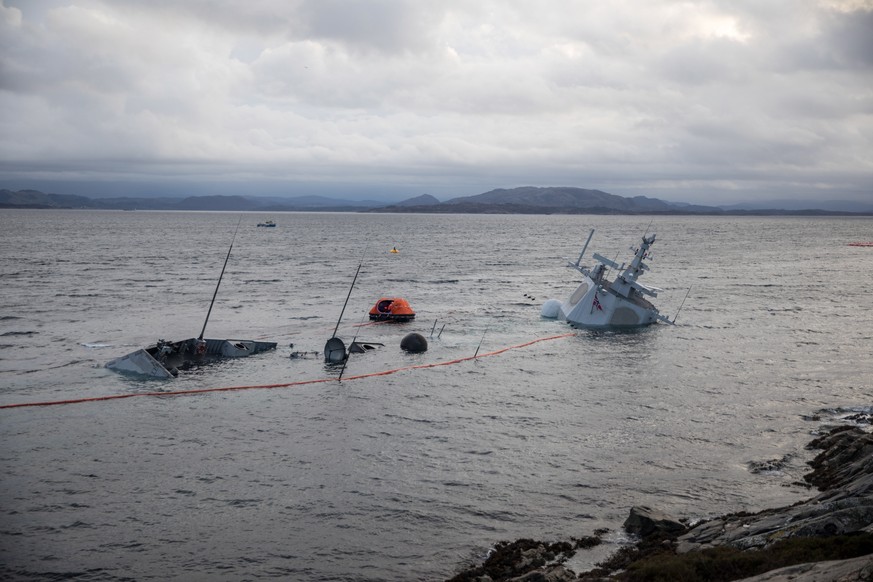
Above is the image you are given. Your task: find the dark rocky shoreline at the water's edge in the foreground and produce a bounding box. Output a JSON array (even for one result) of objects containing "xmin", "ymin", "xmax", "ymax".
[{"xmin": 450, "ymin": 426, "xmax": 873, "ymax": 582}]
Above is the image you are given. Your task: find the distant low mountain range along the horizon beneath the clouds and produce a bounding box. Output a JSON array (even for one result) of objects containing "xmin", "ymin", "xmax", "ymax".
[{"xmin": 0, "ymin": 186, "xmax": 873, "ymax": 215}]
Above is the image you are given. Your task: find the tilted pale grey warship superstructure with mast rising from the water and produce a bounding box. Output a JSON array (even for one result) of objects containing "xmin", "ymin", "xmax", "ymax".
[{"xmin": 542, "ymin": 230, "xmax": 672, "ymax": 328}]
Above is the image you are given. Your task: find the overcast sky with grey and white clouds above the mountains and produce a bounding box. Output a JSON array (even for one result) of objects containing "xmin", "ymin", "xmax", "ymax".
[{"xmin": 0, "ymin": 0, "xmax": 873, "ymax": 204}]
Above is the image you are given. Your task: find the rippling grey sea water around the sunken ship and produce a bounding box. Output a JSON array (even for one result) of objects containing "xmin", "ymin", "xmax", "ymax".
[{"xmin": 0, "ymin": 211, "xmax": 873, "ymax": 580}]
